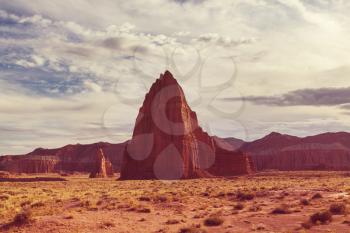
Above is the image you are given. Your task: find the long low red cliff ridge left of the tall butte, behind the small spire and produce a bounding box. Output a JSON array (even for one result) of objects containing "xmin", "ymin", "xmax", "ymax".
[{"xmin": 0, "ymin": 142, "xmax": 125, "ymax": 173}]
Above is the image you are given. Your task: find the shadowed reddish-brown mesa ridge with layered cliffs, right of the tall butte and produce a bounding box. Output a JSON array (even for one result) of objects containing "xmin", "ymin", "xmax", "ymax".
[{"xmin": 240, "ymin": 132, "xmax": 350, "ymax": 171}]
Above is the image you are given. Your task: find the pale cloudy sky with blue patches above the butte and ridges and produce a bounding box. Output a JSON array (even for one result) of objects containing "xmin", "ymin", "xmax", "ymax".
[{"xmin": 0, "ymin": 0, "xmax": 350, "ymax": 154}]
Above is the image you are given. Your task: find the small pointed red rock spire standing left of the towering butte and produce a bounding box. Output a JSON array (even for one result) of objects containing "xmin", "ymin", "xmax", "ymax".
[{"xmin": 89, "ymin": 148, "xmax": 114, "ymax": 178}]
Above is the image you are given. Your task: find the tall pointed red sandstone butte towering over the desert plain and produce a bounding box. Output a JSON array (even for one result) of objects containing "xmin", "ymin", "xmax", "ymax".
[{"xmin": 120, "ymin": 71, "xmax": 255, "ymax": 180}]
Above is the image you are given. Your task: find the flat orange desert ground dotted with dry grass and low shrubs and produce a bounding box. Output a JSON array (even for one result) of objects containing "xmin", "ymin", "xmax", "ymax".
[{"xmin": 0, "ymin": 172, "xmax": 350, "ymax": 233}]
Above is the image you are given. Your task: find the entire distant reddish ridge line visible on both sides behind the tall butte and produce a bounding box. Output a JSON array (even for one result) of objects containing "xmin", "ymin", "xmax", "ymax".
[{"xmin": 0, "ymin": 125, "xmax": 350, "ymax": 173}]
